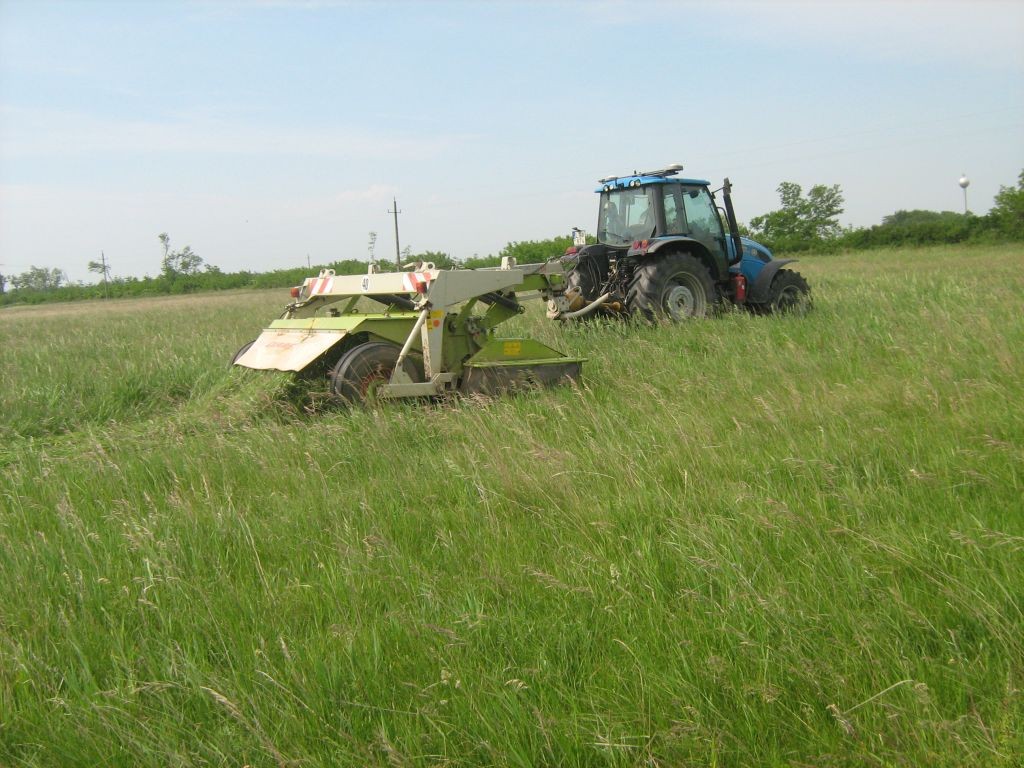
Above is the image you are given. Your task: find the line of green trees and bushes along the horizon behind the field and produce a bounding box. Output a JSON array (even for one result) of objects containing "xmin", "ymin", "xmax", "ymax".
[{"xmin": 0, "ymin": 171, "xmax": 1024, "ymax": 306}]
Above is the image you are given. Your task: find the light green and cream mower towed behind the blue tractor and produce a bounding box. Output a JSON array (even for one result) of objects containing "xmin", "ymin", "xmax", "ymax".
[{"xmin": 232, "ymin": 259, "xmax": 584, "ymax": 402}]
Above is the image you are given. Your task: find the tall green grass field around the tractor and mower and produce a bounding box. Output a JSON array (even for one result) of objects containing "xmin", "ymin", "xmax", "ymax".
[{"xmin": 0, "ymin": 246, "xmax": 1024, "ymax": 766}]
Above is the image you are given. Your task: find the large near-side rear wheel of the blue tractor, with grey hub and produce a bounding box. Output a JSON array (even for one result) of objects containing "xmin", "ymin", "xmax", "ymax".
[{"xmin": 626, "ymin": 253, "xmax": 716, "ymax": 323}]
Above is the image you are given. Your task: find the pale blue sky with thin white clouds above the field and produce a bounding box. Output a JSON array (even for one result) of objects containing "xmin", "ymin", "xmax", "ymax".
[{"xmin": 0, "ymin": 0, "xmax": 1024, "ymax": 281}]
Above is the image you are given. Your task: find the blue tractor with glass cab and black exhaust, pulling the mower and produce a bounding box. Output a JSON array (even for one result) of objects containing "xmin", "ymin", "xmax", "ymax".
[{"xmin": 563, "ymin": 165, "xmax": 810, "ymax": 322}]
